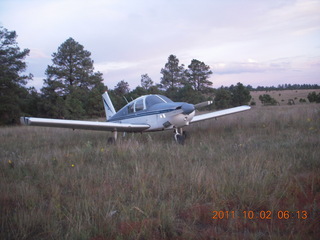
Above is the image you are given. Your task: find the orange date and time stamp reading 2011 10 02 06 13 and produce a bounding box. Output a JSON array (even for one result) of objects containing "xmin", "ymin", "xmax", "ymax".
[{"xmin": 212, "ymin": 210, "xmax": 309, "ymax": 220}]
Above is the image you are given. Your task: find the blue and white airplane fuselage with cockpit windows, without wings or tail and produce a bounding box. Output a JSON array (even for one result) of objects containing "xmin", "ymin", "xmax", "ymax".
[{"xmin": 108, "ymin": 95, "xmax": 195, "ymax": 131}]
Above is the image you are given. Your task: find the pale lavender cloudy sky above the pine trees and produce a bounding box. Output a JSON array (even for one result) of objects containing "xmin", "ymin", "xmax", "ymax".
[{"xmin": 0, "ymin": 0, "xmax": 320, "ymax": 89}]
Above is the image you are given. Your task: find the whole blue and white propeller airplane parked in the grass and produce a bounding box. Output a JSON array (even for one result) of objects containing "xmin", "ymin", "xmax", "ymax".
[{"xmin": 20, "ymin": 92, "xmax": 250, "ymax": 144}]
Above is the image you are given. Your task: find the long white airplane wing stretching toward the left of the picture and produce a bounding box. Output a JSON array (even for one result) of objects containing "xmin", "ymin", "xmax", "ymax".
[{"xmin": 20, "ymin": 117, "xmax": 150, "ymax": 132}]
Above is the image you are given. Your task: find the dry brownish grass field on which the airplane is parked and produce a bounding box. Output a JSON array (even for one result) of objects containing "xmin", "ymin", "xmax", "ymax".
[{"xmin": 0, "ymin": 104, "xmax": 320, "ymax": 240}]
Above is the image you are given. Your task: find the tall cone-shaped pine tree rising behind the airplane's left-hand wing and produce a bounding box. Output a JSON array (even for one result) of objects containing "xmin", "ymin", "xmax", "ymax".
[{"xmin": 41, "ymin": 38, "xmax": 104, "ymax": 118}]
